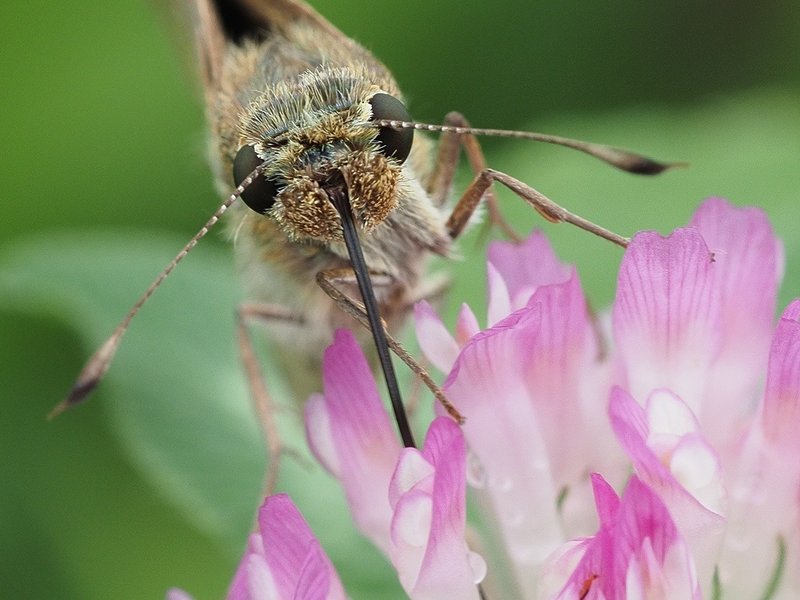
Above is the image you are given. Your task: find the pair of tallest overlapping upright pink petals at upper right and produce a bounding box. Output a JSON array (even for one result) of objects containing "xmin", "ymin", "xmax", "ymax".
[{"xmin": 613, "ymin": 198, "xmax": 783, "ymax": 451}]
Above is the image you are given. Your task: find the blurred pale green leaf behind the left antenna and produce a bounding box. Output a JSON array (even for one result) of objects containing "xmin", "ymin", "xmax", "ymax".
[{"xmin": 0, "ymin": 232, "xmax": 397, "ymax": 598}]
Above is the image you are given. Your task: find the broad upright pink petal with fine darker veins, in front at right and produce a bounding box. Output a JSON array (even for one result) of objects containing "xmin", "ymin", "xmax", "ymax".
[{"xmin": 614, "ymin": 228, "xmax": 722, "ymax": 412}]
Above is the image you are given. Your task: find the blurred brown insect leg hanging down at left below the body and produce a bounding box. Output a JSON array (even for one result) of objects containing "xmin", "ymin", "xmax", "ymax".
[{"xmin": 236, "ymin": 303, "xmax": 300, "ymax": 494}]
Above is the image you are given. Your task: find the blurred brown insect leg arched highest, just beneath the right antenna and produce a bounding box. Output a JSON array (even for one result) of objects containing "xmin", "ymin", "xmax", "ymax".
[{"xmin": 427, "ymin": 112, "xmax": 522, "ymax": 241}]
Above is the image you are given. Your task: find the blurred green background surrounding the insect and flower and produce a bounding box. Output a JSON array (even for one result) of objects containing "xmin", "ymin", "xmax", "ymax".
[{"xmin": 0, "ymin": 0, "xmax": 800, "ymax": 598}]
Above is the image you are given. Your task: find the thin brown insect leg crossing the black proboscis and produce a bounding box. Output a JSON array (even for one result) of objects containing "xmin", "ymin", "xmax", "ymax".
[{"xmin": 317, "ymin": 268, "xmax": 464, "ymax": 423}]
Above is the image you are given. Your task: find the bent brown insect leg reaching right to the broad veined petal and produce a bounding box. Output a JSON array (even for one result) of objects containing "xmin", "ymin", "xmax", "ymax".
[{"xmin": 447, "ymin": 169, "xmax": 630, "ymax": 248}]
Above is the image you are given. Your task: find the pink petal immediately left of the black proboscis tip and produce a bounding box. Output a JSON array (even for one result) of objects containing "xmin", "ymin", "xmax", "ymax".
[{"xmin": 306, "ymin": 329, "xmax": 401, "ymax": 553}]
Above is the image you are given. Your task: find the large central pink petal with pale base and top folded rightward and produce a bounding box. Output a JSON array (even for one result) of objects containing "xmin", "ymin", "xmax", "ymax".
[{"xmin": 444, "ymin": 304, "xmax": 564, "ymax": 594}]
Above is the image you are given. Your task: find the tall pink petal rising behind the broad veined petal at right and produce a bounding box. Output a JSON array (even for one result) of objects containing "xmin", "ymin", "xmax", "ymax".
[{"xmin": 690, "ymin": 198, "xmax": 783, "ymax": 451}]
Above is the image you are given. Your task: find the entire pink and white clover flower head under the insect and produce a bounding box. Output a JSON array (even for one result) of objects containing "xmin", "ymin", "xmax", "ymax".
[{"xmin": 172, "ymin": 199, "xmax": 800, "ymax": 600}]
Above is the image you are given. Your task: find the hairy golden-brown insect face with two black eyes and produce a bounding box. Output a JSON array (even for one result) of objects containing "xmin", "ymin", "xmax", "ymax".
[{"xmin": 232, "ymin": 69, "xmax": 413, "ymax": 243}]
